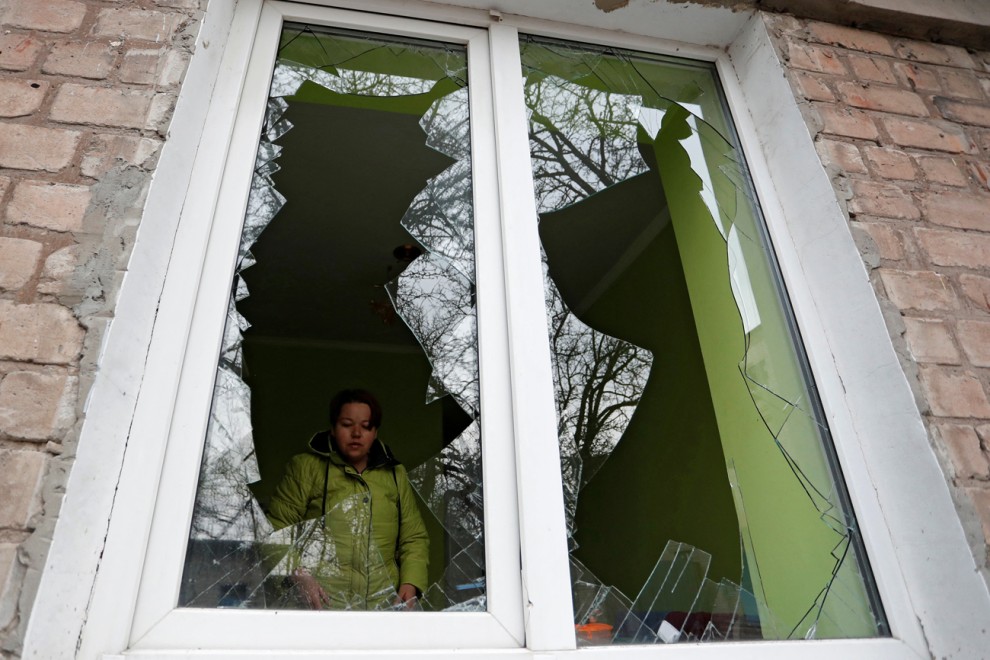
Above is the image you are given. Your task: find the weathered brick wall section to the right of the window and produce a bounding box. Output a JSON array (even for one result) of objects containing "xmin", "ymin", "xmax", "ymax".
[{"xmin": 765, "ymin": 15, "xmax": 990, "ymax": 576}]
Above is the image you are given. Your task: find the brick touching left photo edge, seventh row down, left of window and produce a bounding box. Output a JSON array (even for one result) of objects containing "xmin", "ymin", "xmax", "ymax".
[{"xmin": 0, "ymin": 300, "xmax": 83, "ymax": 364}]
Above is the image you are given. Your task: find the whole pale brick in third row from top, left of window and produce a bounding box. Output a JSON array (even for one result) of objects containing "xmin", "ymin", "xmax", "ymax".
[{"xmin": 51, "ymin": 84, "xmax": 154, "ymax": 128}]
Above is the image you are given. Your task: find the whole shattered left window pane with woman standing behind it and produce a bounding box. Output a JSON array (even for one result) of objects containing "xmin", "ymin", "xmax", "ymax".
[{"xmin": 179, "ymin": 24, "xmax": 486, "ymax": 611}]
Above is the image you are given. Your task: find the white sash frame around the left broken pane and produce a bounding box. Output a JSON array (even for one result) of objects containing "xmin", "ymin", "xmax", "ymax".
[{"xmin": 128, "ymin": 2, "xmax": 536, "ymax": 649}]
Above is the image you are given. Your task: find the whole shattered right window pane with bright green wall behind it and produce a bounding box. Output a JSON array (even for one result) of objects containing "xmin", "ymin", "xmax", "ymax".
[{"xmin": 520, "ymin": 37, "xmax": 889, "ymax": 645}]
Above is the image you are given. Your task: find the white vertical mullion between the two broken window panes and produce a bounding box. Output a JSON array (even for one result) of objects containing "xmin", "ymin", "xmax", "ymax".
[{"xmin": 490, "ymin": 24, "xmax": 575, "ymax": 651}]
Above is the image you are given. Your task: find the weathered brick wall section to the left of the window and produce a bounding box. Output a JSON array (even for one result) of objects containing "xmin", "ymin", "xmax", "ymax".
[{"xmin": 0, "ymin": 0, "xmax": 206, "ymax": 658}]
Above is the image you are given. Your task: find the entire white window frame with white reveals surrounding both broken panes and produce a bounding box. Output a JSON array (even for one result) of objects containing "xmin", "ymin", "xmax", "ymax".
[{"xmin": 25, "ymin": 0, "xmax": 990, "ymax": 659}]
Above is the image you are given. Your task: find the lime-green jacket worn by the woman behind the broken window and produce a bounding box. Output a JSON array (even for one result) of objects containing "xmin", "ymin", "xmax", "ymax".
[{"xmin": 268, "ymin": 431, "xmax": 430, "ymax": 610}]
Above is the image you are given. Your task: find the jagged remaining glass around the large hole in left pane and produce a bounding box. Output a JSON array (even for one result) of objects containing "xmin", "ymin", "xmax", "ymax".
[{"xmin": 179, "ymin": 26, "xmax": 487, "ymax": 611}]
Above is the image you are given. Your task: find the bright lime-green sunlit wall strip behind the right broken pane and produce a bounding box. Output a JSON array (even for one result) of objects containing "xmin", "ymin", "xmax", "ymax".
[{"xmin": 655, "ymin": 108, "xmax": 876, "ymax": 637}]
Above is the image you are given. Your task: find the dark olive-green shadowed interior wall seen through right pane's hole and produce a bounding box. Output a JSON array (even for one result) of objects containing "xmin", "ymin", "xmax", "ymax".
[{"xmin": 575, "ymin": 220, "xmax": 742, "ymax": 598}]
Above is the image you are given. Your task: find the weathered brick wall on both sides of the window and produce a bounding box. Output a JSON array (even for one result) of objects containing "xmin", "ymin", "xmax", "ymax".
[{"xmin": 0, "ymin": 0, "xmax": 990, "ymax": 657}]
